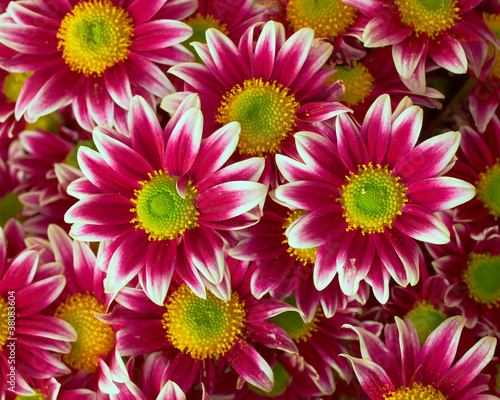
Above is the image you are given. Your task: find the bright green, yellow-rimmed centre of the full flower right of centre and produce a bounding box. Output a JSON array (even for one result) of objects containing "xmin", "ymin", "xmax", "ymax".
[{"xmin": 339, "ymin": 162, "xmax": 408, "ymax": 233}]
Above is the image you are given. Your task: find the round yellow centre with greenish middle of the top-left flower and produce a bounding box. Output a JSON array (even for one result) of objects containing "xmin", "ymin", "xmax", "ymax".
[{"xmin": 57, "ymin": 0, "xmax": 134, "ymax": 76}]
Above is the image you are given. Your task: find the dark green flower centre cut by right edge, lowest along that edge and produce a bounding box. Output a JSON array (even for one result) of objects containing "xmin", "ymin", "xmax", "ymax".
[{"xmin": 463, "ymin": 253, "xmax": 500, "ymax": 307}]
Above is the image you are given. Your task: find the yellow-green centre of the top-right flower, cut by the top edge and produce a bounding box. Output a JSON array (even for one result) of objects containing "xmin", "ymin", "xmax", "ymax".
[{"xmin": 394, "ymin": 0, "xmax": 459, "ymax": 38}]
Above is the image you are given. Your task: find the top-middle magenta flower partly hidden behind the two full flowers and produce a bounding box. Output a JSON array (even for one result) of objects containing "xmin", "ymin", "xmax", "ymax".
[{"xmin": 162, "ymin": 21, "xmax": 349, "ymax": 156}]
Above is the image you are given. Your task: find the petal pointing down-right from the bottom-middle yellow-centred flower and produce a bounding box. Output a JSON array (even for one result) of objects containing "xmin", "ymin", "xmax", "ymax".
[{"xmin": 225, "ymin": 339, "xmax": 274, "ymax": 392}]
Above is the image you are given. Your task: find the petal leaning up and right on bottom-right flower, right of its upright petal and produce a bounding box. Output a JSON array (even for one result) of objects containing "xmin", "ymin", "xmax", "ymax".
[{"xmin": 420, "ymin": 316, "xmax": 466, "ymax": 385}]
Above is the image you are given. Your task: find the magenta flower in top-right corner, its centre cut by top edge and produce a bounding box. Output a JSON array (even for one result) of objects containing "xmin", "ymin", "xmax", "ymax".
[{"xmin": 344, "ymin": 0, "xmax": 500, "ymax": 93}]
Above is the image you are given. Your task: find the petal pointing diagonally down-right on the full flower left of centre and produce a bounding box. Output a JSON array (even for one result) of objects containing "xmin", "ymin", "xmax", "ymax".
[{"xmin": 184, "ymin": 226, "xmax": 225, "ymax": 285}]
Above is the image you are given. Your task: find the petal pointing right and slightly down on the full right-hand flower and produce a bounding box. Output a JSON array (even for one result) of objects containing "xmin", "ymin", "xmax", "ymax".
[{"xmin": 394, "ymin": 204, "xmax": 450, "ymax": 244}]
